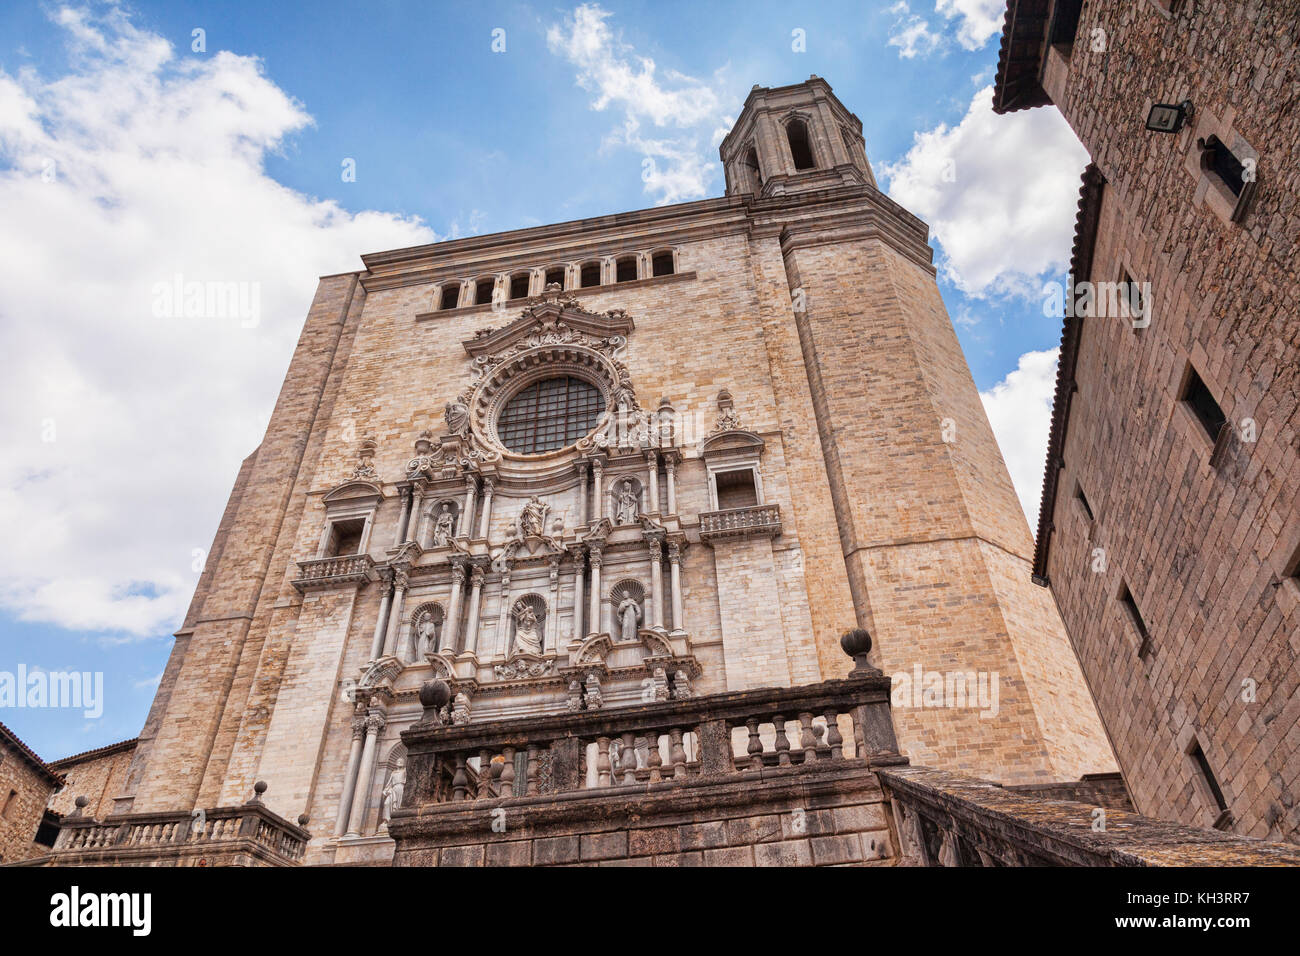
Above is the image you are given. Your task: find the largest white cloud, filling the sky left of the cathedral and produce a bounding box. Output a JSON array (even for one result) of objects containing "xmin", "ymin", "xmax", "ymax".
[{"xmin": 0, "ymin": 8, "xmax": 437, "ymax": 635}]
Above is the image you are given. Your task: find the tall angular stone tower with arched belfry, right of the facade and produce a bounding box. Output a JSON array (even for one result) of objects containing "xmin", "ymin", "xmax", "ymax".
[{"xmin": 720, "ymin": 77, "xmax": 1114, "ymax": 782}]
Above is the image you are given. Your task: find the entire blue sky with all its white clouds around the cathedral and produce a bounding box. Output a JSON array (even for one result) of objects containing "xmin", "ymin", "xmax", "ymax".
[{"xmin": 0, "ymin": 0, "xmax": 1086, "ymax": 758}]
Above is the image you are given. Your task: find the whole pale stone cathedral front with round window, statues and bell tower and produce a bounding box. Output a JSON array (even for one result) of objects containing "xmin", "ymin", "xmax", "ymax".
[{"xmin": 96, "ymin": 77, "xmax": 1114, "ymax": 862}]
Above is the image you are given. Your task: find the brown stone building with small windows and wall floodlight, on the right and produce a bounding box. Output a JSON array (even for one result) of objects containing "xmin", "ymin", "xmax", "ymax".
[{"xmin": 995, "ymin": 0, "xmax": 1300, "ymax": 840}]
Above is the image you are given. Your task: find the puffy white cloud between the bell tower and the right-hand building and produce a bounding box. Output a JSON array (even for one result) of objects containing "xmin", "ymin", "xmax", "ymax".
[{"xmin": 880, "ymin": 87, "xmax": 1088, "ymax": 297}]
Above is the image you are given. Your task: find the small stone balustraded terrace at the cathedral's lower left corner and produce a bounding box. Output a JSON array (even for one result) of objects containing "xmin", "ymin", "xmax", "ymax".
[{"xmin": 25, "ymin": 783, "xmax": 311, "ymax": 866}]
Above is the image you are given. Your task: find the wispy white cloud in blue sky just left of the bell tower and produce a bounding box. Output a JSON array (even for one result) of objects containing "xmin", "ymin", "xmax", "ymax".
[{"xmin": 546, "ymin": 4, "xmax": 731, "ymax": 206}]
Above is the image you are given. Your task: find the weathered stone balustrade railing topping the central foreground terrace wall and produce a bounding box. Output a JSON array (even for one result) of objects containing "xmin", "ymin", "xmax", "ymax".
[{"xmin": 402, "ymin": 676, "xmax": 902, "ymax": 808}]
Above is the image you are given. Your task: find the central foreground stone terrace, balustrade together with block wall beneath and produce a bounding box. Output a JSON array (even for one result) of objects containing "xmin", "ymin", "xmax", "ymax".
[{"xmin": 389, "ymin": 672, "xmax": 906, "ymax": 866}]
